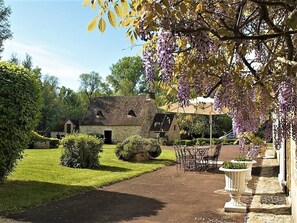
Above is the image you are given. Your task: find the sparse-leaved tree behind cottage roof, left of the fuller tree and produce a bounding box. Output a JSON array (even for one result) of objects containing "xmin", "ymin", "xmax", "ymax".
[{"xmin": 79, "ymin": 71, "xmax": 111, "ymax": 101}]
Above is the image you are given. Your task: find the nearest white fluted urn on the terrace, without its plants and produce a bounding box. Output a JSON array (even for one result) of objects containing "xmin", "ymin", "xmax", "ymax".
[{"xmin": 219, "ymin": 167, "xmax": 249, "ymax": 213}]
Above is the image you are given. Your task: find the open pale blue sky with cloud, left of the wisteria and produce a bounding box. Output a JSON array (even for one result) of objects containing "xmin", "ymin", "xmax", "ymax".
[{"xmin": 2, "ymin": 0, "xmax": 141, "ymax": 91}]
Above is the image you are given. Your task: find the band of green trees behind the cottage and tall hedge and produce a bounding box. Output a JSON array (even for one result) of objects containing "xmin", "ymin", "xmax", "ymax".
[{"xmin": 4, "ymin": 54, "xmax": 151, "ymax": 131}]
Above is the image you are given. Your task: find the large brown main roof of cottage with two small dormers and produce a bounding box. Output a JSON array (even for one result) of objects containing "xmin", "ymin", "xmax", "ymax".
[{"xmin": 81, "ymin": 95, "xmax": 156, "ymax": 126}]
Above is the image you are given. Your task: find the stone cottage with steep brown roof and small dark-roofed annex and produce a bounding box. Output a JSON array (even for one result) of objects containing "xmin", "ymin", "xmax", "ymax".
[{"xmin": 80, "ymin": 95, "xmax": 180, "ymax": 143}]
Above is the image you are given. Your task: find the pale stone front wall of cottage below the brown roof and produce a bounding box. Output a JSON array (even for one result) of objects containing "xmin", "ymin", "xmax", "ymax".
[{"xmin": 80, "ymin": 125, "xmax": 141, "ymax": 143}]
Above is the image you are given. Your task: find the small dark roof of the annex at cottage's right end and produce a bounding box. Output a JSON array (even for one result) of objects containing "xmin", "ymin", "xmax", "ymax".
[{"xmin": 150, "ymin": 113, "xmax": 174, "ymax": 132}]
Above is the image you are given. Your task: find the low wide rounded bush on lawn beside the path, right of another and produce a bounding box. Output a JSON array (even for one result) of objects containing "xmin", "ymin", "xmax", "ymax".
[{"xmin": 115, "ymin": 135, "xmax": 162, "ymax": 161}]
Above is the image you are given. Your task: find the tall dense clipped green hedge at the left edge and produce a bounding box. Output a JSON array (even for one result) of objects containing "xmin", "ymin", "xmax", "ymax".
[{"xmin": 0, "ymin": 62, "xmax": 41, "ymax": 182}]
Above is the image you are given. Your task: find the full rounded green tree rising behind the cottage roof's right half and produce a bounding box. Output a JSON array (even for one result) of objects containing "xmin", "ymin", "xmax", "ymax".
[{"xmin": 106, "ymin": 56, "xmax": 147, "ymax": 95}]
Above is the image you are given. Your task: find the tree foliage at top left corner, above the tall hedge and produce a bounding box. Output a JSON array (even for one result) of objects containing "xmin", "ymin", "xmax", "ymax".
[{"xmin": 0, "ymin": 0, "xmax": 12, "ymax": 59}]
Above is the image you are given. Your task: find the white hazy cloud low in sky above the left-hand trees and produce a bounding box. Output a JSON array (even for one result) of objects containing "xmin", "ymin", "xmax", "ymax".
[{"xmin": 2, "ymin": 40, "xmax": 89, "ymax": 91}]
